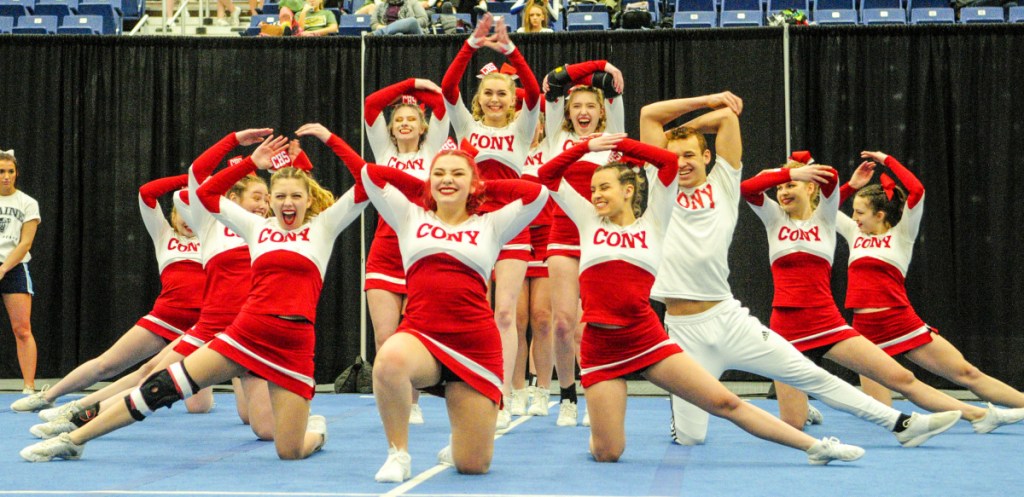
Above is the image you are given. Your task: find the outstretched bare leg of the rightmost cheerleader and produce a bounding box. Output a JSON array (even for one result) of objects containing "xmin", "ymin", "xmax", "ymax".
[{"xmin": 906, "ymin": 334, "xmax": 1024, "ymax": 408}]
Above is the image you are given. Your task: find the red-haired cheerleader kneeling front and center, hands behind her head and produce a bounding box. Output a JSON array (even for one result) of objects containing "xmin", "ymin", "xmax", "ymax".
[{"xmin": 362, "ymin": 150, "xmax": 548, "ymax": 483}]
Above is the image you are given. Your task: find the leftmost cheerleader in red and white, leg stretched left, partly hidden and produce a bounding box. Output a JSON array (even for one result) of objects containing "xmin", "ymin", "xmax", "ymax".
[{"xmin": 10, "ymin": 174, "xmax": 206, "ymax": 421}]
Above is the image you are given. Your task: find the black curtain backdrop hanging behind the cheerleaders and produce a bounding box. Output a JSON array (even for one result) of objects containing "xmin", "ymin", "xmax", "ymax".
[{"xmin": 0, "ymin": 27, "xmax": 1024, "ymax": 387}]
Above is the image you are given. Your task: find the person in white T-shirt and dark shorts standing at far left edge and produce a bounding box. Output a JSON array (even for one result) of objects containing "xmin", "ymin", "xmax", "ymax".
[{"xmin": 0, "ymin": 150, "xmax": 40, "ymax": 395}]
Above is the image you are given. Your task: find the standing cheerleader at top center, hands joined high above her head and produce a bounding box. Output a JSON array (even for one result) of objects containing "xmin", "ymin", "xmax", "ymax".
[{"xmin": 441, "ymin": 14, "xmax": 541, "ymax": 429}]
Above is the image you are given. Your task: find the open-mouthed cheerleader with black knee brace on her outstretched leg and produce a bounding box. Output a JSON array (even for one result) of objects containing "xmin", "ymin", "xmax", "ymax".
[{"xmin": 22, "ymin": 128, "xmax": 366, "ymax": 461}]
